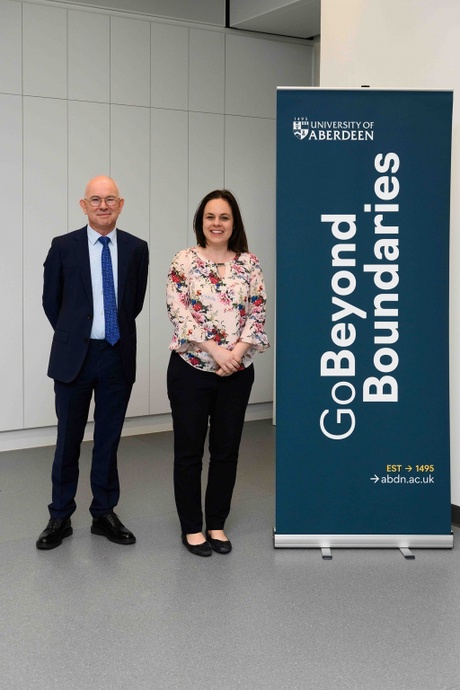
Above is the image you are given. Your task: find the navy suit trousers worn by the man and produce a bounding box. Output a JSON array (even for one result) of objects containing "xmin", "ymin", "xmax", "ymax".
[{"xmin": 48, "ymin": 340, "xmax": 132, "ymax": 518}]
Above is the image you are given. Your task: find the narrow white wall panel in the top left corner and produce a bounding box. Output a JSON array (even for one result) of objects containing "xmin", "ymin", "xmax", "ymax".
[{"xmin": 0, "ymin": 0, "xmax": 22, "ymax": 93}]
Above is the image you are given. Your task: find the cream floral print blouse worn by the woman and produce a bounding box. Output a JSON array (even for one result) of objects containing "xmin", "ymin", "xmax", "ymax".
[{"xmin": 166, "ymin": 247, "xmax": 269, "ymax": 372}]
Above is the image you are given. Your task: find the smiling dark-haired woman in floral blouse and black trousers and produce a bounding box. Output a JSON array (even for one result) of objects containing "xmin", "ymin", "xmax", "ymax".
[{"xmin": 167, "ymin": 189, "xmax": 269, "ymax": 556}]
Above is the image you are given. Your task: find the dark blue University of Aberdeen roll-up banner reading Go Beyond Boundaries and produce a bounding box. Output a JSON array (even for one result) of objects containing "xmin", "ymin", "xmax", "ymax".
[{"xmin": 274, "ymin": 87, "xmax": 453, "ymax": 548}]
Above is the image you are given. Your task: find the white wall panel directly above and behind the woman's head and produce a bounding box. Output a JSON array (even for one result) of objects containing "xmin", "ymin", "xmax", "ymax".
[{"xmin": 187, "ymin": 113, "xmax": 224, "ymax": 246}]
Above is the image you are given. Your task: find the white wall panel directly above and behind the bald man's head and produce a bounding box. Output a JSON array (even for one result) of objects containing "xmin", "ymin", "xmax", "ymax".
[{"xmin": 68, "ymin": 101, "xmax": 110, "ymax": 230}]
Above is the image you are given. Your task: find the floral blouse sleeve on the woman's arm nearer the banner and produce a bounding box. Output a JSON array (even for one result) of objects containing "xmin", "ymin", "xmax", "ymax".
[{"xmin": 239, "ymin": 254, "xmax": 270, "ymax": 352}]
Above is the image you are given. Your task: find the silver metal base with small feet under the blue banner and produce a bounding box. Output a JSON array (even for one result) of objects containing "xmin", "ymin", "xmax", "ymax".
[{"xmin": 273, "ymin": 532, "xmax": 454, "ymax": 560}]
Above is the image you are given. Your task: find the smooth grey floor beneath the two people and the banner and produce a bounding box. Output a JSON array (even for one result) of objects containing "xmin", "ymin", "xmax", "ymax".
[{"xmin": 0, "ymin": 421, "xmax": 460, "ymax": 690}]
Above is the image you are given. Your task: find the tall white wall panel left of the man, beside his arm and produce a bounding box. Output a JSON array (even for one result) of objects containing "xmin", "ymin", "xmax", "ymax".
[{"xmin": 24, "ymin": 98, "xmax": 68, "ymax": 427}]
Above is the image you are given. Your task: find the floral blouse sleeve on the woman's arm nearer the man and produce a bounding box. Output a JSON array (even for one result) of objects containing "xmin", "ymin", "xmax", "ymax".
[{"xmin": 166, "ymin": 250, "xmax": 206, "ymax": 351}]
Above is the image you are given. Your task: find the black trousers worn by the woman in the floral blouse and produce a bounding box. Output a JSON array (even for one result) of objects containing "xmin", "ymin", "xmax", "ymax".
[{"xmin": 167, "ymin": 352, "xmax": 254, "ymax": 534}]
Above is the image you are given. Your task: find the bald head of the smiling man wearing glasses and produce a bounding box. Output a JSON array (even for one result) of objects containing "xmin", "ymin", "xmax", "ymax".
[{"xmin": 80, "ymin": 177, "xmax": 125, "ymax": 235}]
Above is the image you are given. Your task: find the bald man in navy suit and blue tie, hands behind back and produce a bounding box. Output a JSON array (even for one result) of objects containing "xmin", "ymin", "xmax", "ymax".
[{"xmin": 36, "ymin": 176, "xmax": 149, "ymax": 549}]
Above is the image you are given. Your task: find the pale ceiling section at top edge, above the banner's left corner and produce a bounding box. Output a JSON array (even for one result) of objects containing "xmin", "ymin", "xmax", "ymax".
[{"xmin": 229, "ymin": 0, "xmax": 321, "ymax": 38}]
